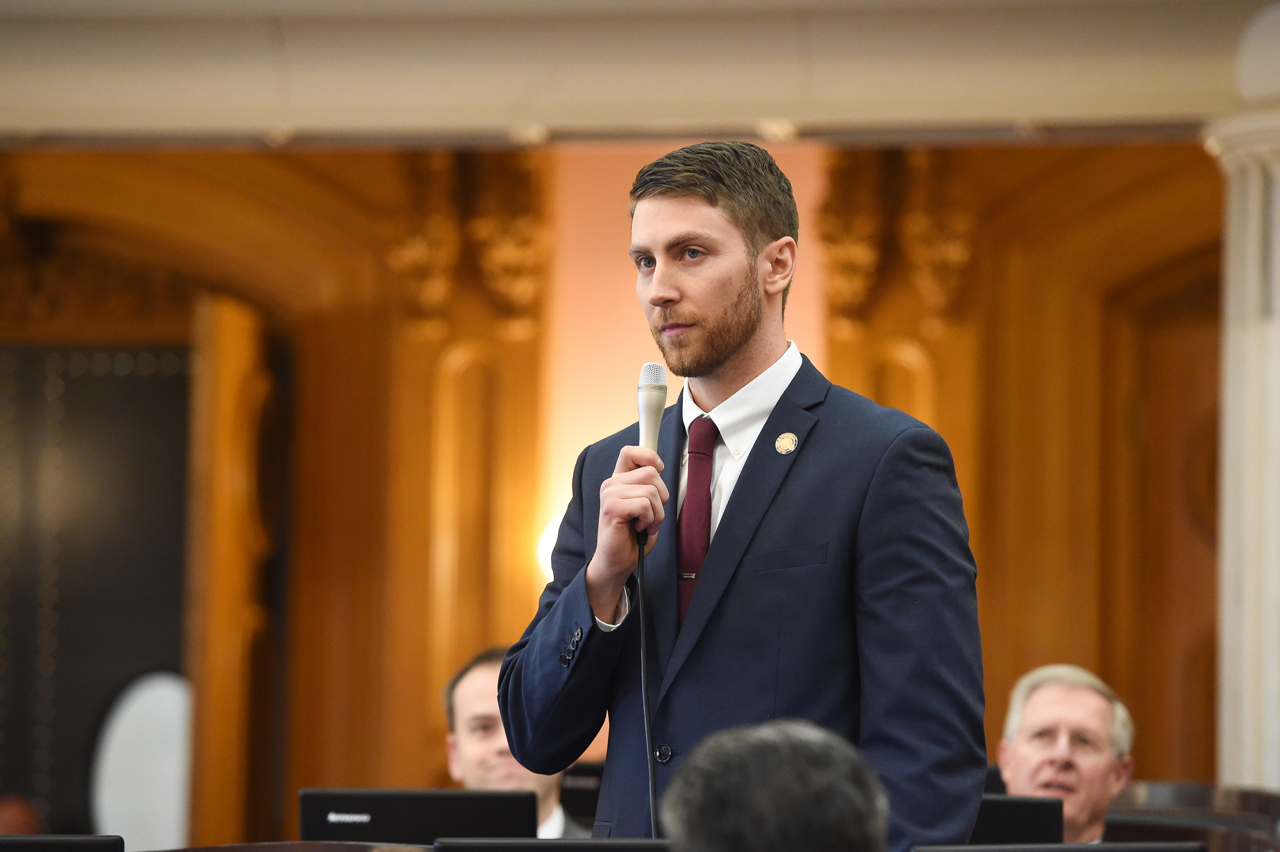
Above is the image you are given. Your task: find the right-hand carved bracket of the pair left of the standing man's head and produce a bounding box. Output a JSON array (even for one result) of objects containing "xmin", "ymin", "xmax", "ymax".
[{"xmin": 466, "ymin": 151, "xmax": 552, "ymax": 316}]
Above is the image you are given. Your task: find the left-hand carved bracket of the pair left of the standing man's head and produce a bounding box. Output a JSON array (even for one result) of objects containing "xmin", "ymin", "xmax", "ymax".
[{"xmin": 387, "ymin": 151, "xmax": 462, "ymax": 317}]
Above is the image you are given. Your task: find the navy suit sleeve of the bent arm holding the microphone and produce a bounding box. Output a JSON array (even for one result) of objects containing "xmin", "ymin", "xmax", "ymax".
[{"xmin": 498, "ymin": 448, "xmax": 636, "ymax": 775}]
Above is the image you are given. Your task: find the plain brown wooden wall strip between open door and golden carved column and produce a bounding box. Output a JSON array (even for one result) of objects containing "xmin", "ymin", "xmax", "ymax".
[{"xmin": 282, "ymin": 301, "xmax": 388, "ymax": 798}]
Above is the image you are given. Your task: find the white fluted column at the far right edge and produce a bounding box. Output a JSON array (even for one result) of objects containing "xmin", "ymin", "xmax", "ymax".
[{"xmin": 1208, "ymin": 110, "xmax": 1280, "ymax": 788}]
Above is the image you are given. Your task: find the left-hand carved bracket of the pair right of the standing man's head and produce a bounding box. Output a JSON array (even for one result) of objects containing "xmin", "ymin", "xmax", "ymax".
[{"xmin": 818, "ymin": 151, "xmax": 884, "ymax": 320}]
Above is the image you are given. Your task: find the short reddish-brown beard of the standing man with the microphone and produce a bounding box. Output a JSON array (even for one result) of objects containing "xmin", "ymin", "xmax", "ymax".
[{"xmin": 649, "ymin": 267, "xmax": 764, "ymax": 379}]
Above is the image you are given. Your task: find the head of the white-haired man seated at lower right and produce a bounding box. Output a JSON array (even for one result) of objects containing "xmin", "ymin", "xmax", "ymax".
[{"xmin": 1000, "ymin": 665, "xmax": 1133, "ymax": 843}]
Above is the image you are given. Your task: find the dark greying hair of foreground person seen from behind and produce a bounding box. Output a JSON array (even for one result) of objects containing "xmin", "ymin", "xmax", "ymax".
[{"xmin": 659, "ymin": 719, "xmax": 888, "ymax": 852}]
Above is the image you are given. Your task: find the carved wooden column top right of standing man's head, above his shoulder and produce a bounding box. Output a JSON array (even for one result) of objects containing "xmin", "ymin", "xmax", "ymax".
[{"xmin": 819, "ymin": 148, "xmax": 975, "ymax": 427}]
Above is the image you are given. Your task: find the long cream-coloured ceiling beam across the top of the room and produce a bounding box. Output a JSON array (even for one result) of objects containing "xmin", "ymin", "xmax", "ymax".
[{"xmin": 0, "ymin": 0, "xmax": 1280, "ymax": 145}]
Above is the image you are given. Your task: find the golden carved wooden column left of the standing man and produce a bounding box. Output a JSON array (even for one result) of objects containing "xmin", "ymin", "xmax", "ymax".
[{"xmin": 379, "ymin": 151, "xmax": 549, "ymax": 785}]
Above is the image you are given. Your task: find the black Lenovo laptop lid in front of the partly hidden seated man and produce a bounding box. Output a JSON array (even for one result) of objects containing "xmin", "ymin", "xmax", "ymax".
[{"xmin": 298, "ymin": 789, "xmax": 538, "ymax": 846}]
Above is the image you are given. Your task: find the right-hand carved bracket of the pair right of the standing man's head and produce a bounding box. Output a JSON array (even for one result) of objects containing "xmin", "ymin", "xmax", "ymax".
[{"xmin": 899, "ymin": 148, "xmax": 977, "ymax": 313}]
